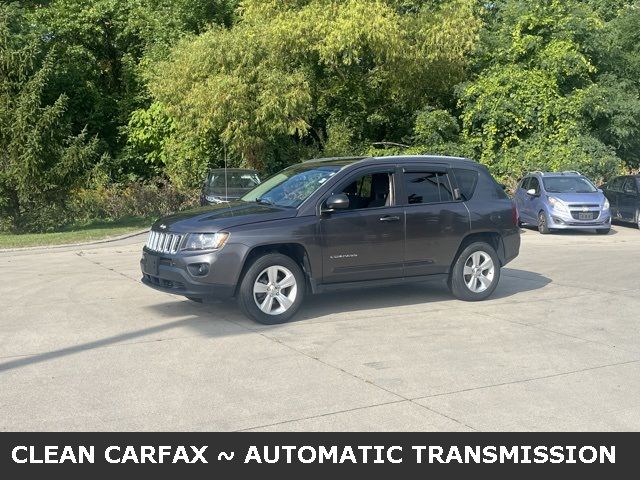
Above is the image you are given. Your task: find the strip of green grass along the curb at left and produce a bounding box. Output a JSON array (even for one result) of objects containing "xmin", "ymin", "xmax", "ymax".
[{"xmin": 0, "ymin": 217, "xmax": 155, "ymax": 248}]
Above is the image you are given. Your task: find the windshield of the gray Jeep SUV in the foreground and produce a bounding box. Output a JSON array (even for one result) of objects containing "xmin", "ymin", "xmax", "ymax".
[{"xmin": 242, "ymin": 164, "xmax": 342, "ymax": 207}]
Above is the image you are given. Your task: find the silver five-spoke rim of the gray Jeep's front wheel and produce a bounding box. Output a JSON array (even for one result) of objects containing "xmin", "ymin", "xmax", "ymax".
[{"xmin": 253, "ymin": 265, "xmax": 298, "ymax": 315}]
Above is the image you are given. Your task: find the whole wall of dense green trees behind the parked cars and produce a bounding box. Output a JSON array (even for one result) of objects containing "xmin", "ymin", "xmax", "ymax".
[{"xmin": 0, "ymin": 0, "xmax": 640, "ymax": 230}]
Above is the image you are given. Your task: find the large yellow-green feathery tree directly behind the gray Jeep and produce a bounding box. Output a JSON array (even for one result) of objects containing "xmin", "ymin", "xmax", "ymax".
[{"xmin": 141, "ymin": 0, "xmax": 479, "ymax": 185}]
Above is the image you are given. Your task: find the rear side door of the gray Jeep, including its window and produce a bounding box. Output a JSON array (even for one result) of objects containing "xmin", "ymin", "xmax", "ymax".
[{"xmin": 400, "ymin": 164, "xmax": 470, "ymax": 277}]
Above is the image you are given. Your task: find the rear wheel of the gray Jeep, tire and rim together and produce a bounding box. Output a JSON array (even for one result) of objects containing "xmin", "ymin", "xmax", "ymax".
[{"xmin": 449, "ymin": 242, "xmax": 500, "ymax": 302}]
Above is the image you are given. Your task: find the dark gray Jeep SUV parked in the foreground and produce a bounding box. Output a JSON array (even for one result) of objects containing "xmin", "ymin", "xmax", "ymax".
[{"xmin": 140, "ymin": 156, "xmax": 520, "ymax": 324}]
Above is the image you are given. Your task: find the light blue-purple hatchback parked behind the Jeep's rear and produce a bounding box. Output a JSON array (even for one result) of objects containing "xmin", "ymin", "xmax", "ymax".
[{"xmin": 515, "ymin": 172, "xmax": 611, "ymax": 235}]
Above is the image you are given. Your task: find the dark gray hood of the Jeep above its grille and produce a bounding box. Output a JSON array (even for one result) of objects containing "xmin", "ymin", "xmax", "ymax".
[{"xmin": 153, "ymin": 201, "xmax": 298, "ymax": 233}]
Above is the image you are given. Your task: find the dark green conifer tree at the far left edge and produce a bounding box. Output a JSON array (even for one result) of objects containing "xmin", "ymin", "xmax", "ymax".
[{"xmin": 0, "ymin": 5, "xmax": 97, "ymax": 230}]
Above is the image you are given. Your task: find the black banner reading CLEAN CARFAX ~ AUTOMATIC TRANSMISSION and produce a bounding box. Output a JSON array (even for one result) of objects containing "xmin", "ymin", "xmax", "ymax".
[{"xmin": 0, "ymin": 433, "xmax": 640, "ymax": 478}]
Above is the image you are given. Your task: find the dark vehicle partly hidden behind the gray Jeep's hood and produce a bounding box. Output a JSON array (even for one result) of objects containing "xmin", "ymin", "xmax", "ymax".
[{"xmin": 200, "ymin": 168, "xmax": 260, "ymax": 206}]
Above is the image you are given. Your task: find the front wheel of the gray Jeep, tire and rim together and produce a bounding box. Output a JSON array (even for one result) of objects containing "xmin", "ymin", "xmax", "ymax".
[{"xmin": 238, "ymin": 253, "xmax": 305, "ymax": 325}]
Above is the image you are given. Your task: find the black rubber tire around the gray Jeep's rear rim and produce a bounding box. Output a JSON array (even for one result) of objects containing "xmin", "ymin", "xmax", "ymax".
[{"xmin": 448, "ymin": 242, "xmax": 500, "ymax": 302}]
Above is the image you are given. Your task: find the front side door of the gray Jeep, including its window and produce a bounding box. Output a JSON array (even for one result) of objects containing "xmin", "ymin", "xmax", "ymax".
[{"xmin": 320, "ymin": 167, "xmax": 404, "ymax": 283}]
